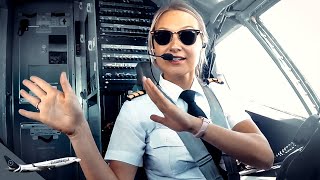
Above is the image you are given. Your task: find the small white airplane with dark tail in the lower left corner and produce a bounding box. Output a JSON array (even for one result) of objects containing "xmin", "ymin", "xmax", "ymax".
[{"xmin": 4, "ymin": 156, "xmax": 81, "ymax": 172}]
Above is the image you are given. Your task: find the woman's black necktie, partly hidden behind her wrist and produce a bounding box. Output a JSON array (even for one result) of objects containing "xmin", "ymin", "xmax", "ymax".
[{"xmin": 179, "ymin": 90, "xmax": 221, "ymax": 166}]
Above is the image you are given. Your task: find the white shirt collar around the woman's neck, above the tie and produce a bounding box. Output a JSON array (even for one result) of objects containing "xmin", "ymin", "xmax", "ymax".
[{"xmin": 159, "ymin": 74, "xmax": 204, "ymax": 103}]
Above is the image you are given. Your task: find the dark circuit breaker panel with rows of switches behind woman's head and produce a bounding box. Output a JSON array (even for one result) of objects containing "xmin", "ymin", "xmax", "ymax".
[{"xmin": 96, "ymin": 0, "xmax": 156, "ymax": 91}]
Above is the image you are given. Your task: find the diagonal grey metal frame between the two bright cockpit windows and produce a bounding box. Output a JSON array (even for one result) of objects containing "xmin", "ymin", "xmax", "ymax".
[{"xmin": 230, "ymin": 12, "xmax": 320, "ymax": 115}]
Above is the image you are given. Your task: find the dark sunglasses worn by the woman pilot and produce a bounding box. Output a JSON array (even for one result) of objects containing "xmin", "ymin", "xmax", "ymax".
[{"xmin": 150, "ymin": 29, "xmax": 201, "ymax": 46}]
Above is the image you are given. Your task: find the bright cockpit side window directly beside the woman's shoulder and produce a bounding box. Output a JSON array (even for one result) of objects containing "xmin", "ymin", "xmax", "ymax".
[{"xmin": 216, "ymin": 27, "xmax": 310, "ymax": 117}]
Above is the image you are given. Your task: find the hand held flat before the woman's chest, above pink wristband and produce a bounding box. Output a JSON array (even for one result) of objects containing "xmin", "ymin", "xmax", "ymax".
[{"xmin": 142, "ymin": 77, "xmax": 201, "ymax": 133}]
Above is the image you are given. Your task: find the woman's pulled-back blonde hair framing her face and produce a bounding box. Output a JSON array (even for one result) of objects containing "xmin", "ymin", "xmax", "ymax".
[{"xmin": 148, "ymin": 0, "xmax": 209, "ymax": 77}]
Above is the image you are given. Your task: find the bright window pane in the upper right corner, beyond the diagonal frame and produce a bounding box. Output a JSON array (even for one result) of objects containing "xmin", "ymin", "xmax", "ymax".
[{"xmin": 260, "ymin": 0, "xmax": 320, "ymax": 101}]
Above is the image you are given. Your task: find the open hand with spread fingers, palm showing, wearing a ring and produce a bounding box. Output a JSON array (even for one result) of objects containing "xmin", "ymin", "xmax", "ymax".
[{"xmin": 19, "ymin": 72, "xmax": 84, "ymax": 136}]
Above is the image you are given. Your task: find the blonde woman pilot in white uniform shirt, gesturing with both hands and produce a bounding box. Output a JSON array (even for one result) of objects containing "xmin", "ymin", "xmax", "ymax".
[{"xmin": 19, "ymin": 1, "xmax": 273, "ymax": 179}]
